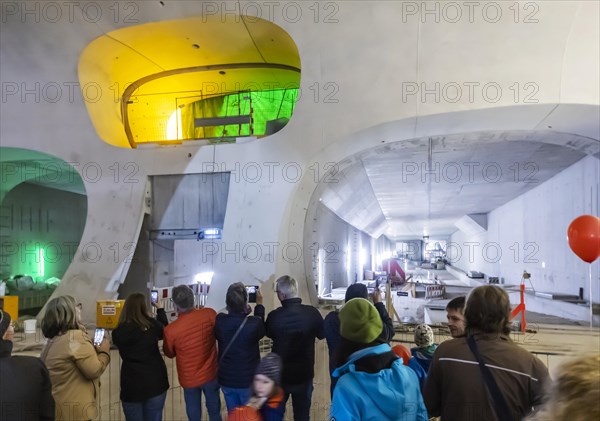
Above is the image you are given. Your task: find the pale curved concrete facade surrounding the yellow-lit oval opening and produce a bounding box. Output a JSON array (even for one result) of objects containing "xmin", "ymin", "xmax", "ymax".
[{"xmin": 0, "ymin": 1, "xmax": 600, "ymax": 319}]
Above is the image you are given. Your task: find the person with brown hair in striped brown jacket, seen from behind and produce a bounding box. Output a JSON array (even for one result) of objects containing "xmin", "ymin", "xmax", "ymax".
[{"xmin": 424, "ymin": 285, "xmax": 549, "ymax": 421}]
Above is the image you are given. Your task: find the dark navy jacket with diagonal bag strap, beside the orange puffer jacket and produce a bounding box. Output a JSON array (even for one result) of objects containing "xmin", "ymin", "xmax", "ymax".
[{"xmin": 215, "ymin": 304, "xmax": 265, "ymax": 389}]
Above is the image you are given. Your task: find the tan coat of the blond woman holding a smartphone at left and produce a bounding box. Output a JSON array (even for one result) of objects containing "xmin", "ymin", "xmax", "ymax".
[{"xmin": 40, "ymin": 329, "xmax": 110, "ymax": 421}]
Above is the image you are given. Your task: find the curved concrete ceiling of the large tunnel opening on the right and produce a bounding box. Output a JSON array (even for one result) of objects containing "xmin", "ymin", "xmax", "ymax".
[{"xmin": 315, "ymin": 128, "xmax": 598, "ymax": 240}]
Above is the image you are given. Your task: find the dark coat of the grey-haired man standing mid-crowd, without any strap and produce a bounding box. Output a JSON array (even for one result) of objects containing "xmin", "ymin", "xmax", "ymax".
[{"xmin": 267, "ymin": 298, "xmax": 325, "ymax": 385}]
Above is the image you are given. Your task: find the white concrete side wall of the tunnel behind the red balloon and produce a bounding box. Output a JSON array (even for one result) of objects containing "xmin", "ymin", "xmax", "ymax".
[{"xmin": 450, "ymin": 156, "xmax": 600, "ymax": 302}]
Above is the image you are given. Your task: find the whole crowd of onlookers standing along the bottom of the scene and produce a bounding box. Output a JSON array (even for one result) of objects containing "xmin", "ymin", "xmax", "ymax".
[{"xmin": 0, "ymin": 276, "xmax": 600, "ymax": 421}]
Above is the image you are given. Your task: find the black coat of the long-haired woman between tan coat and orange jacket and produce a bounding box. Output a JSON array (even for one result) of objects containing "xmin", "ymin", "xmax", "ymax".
[{"xmin": 112, "ymin": 309, "xmax": 169, "ymax": 402}]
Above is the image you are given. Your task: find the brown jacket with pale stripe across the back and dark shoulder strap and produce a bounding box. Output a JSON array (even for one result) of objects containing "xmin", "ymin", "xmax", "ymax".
[{"xmin": 423, "ymin": 333, "xmax": 550, "ymax": 421}]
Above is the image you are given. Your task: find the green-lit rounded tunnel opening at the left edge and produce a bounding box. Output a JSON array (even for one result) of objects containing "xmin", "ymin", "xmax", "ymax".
[{"xmin": 0, "ymin": 147, "xmax": 87, "ymax": 318}]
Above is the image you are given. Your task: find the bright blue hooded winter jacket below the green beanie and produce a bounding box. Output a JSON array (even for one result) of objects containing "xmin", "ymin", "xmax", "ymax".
[{"xmin": 331, "ymin": 344, "xmax": 428, "ymax": 421}]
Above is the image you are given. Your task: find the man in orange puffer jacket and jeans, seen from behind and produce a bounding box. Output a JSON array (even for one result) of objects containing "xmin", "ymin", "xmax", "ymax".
[{"xmin": 163, "ymin": 285, "xmax": 221, "ymax": 421}]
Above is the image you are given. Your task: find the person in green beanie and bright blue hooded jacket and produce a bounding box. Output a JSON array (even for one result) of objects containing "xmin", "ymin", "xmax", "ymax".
[{"xmin": 331, "ymin": 298, "xmax": 428, "ymax": 421}]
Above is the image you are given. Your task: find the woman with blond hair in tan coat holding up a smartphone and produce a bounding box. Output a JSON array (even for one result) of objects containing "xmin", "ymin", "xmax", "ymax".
[{"xmin": 40, "ymin": 295, "xmax": 110, "ymax": 420}]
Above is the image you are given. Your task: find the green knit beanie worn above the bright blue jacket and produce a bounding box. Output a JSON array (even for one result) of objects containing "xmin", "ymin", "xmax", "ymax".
[{"xmin": 340, "ymin": 298, "xmax": 383, "ymax": 344}]
